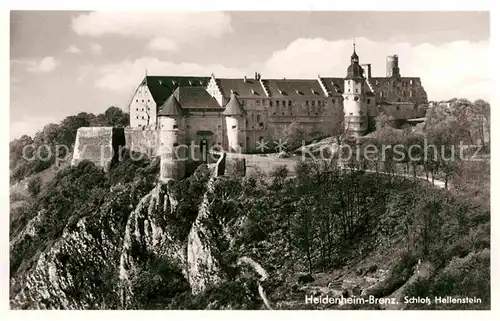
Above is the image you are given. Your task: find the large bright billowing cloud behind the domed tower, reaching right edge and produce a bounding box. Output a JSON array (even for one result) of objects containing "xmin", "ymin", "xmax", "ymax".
[{"xmin": 257, "ymin": 38, "xmax": 491, "ymax": 100}]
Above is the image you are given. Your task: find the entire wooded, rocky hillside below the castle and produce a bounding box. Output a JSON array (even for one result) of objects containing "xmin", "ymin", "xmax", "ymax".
[{"xmin": 10, "ymin": 97, "xmax": 491, "ymax": 309}]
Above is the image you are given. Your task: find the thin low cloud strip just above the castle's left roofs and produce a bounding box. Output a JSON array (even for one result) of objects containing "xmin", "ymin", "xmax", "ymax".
[{"xmin": 96, "ymin": 57, "xmax": 245, "ymax": 93}]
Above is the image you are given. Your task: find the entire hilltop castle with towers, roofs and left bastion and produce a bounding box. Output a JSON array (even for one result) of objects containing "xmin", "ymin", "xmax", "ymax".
[{"xmin": 72, "ymin": 46, "xmax": 427, "ymax": 181}]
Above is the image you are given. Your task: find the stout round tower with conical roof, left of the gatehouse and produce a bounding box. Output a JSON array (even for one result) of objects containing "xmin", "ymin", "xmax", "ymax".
[{"xmin": 158, "ymin": 95, "xmax": 188, "ymax": 183}]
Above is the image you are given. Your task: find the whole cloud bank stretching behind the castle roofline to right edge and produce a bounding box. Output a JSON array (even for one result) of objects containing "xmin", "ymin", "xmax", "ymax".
[{"xmin": 92, "ymin": 38, "xmax": 491, "ymax": 100}]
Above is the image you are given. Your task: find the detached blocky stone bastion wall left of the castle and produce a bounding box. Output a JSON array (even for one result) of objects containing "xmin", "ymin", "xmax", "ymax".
[{"xmin": 71, "ymin": 127, "xmax": 113, "ymax": 168}]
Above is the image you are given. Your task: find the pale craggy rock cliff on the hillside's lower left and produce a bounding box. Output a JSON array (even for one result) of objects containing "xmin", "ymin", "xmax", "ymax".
[{"xmin": 11, "ymin": 156, "xmax": 257, "ymax": 309}]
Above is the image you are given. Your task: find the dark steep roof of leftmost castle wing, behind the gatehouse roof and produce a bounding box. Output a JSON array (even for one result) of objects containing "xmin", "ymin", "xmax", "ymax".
[{"xmin": 142, "ymin": 76, "xmax": 210, "ymax": 106}]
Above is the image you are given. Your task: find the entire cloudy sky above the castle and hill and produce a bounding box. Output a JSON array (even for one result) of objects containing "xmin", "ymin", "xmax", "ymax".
[{"xmin": 10, "ymin": 11, "xmax": 491, "ymax": 138}]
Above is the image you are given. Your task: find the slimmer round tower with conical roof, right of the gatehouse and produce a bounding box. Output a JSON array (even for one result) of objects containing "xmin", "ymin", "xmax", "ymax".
[{"xmin": 223, "ymin": 93, "xmax": 245, "ymax": 153}]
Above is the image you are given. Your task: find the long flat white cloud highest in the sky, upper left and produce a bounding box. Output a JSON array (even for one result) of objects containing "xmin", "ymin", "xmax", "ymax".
[{"xmin": 72, "ymin": 11, "xmax": 232, "ymax": 50}]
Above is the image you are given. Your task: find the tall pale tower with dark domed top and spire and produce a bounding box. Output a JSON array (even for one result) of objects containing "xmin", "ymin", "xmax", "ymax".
[{"xmin": 343, "ymin": 45, "xmax": 367, "ymax": 137}]
